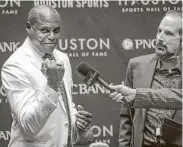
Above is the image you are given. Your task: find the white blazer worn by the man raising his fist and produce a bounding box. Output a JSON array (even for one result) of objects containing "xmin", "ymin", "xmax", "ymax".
[{"xmin": 1, "ymin": 38, "xmax": 87, "ymax": 147}]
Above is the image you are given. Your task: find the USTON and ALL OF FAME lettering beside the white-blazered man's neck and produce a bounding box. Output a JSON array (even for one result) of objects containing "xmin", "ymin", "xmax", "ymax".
[{"xmin": 58, "ymin": 38, "xmax": 111, "ymax": 58}]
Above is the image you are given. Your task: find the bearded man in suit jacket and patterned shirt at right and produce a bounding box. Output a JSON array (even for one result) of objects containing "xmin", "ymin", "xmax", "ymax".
[{"xmin": 114, "ymin": 11, "xmax": 182, "ymax": 147}]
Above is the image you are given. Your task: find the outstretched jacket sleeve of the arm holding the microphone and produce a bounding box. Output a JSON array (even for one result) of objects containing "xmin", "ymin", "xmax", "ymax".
[{"xmin": 132, "ymin": 88, "xmax": 182, "ymax": 110}]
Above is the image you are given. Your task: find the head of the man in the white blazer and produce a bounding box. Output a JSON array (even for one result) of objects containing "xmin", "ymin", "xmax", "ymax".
[{"xmin": 26, "ymin": 5, "xmax": 61, "ymax": 53}]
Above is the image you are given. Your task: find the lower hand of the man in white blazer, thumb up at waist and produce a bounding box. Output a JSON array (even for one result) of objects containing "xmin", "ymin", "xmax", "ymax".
[{"xmin": 75, "ymin": 105, "xmax": 92, "ymax": 130}]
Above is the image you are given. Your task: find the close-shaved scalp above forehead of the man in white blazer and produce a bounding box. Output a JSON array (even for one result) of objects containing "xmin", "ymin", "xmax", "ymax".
[{"xmin": 28, "ymin": 5, "xmax": 60, "ymax": 25}]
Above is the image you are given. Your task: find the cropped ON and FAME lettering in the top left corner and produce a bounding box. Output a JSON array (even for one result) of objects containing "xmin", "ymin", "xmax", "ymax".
[{"xmin": 0, "ymin": 0, "xmax": 21, "ymax": 15}]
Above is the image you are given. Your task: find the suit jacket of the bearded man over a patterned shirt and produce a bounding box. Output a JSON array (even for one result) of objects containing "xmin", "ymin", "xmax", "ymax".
[{"xmin": 119, "ymin": 54, "xmax": 182, "ymax": 147}]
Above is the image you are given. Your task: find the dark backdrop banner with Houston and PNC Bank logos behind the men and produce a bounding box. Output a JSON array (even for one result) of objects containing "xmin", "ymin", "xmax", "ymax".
[{"xmin": 0, "ymin": 0, "xmax": 182, "ymax": 147}]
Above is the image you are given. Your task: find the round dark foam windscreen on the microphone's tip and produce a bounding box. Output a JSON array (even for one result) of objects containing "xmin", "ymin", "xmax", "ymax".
[{"xmin": 77, "ymin": 62, "xmax": 92, "ymax": 76}]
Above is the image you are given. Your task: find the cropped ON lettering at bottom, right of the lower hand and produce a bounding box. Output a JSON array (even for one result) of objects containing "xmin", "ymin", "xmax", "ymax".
[{"xmin": 91, "ymin": 125, "xmax": 114, "ymax": 147}]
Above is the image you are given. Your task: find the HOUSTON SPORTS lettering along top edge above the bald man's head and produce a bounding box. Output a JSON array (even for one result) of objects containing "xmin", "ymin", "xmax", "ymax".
[{"xmin": 34, "ymin": 0, "xmax": 109, "ymax": 8}]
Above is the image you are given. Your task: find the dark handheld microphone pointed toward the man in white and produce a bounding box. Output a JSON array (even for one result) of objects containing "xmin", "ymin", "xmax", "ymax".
[{"xmin": 77, "ymin": 62, "xmax": 116, "ymax": 92}]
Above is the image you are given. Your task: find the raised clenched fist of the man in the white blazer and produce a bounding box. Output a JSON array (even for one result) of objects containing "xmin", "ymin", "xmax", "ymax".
[{"xmin": 42, "ymin": 59, "xmax": 65, "ymax": 91}]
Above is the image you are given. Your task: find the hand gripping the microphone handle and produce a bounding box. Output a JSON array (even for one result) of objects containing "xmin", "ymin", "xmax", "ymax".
[{"xmin": 109, "ymin": 85, "xmax": 136, "ymax": 102}]
